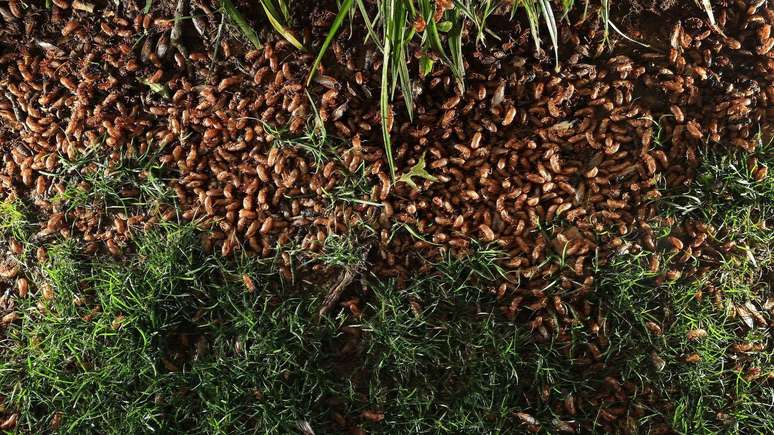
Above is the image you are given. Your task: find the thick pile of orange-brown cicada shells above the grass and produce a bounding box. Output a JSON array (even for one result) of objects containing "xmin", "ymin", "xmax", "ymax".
[{"xmin": 0, "ymin": 0, "xmax": 774, "ymax": 291}]
